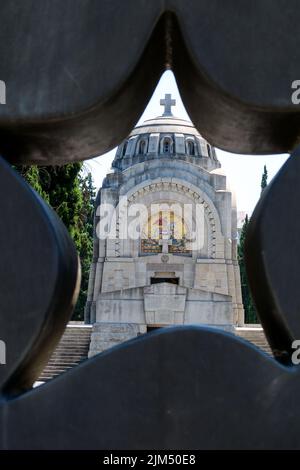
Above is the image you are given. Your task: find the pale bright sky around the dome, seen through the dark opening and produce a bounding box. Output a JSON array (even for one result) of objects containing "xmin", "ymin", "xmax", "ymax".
[{"xmin": 86, "ymin": 71, "xmax": 288, "ymax": 214}]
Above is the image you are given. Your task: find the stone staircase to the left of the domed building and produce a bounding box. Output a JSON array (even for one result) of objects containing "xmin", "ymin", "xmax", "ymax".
[{"xmin": 39, "ymin": 322, "xmax": 92, "ymax": 382}]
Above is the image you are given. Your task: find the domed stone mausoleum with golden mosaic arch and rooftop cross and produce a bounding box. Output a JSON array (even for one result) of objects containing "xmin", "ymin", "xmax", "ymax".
[{"xmin": 85, "ymin": 94, "xmax": 244, "ymax": 356}]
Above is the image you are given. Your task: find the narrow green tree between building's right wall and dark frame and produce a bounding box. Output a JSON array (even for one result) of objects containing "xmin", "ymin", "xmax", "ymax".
[{"xmin": 238, "ymin": 215, "xmax": 259, "ymax": 323}]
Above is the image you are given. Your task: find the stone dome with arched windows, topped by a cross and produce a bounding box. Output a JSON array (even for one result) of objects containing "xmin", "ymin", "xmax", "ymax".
[{"xmin": 112, "ymin": 94, "xmax": 220, "ymax": 171}]
